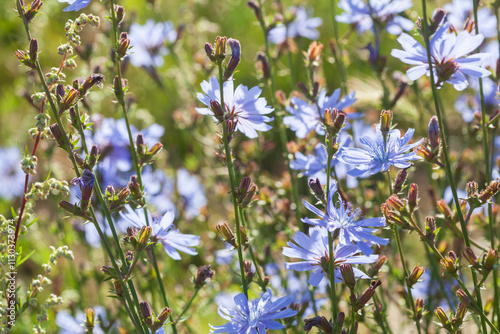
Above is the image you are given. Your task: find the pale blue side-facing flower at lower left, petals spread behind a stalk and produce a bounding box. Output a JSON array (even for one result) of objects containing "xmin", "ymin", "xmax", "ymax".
[{"xmin": 120, "ymin": 205, "xmax": 200, "ymax": 260}]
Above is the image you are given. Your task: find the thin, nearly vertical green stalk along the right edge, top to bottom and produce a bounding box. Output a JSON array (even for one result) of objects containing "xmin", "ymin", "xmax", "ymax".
[{"xmin": 472, "ymin": 1, "xmax": 500, "ymax": 323}]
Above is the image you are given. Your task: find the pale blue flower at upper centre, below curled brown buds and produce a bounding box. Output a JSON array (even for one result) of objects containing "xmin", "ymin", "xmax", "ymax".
[{"xmin": 196, "ymin": 77, "xmax": 274, "ymax": 138}]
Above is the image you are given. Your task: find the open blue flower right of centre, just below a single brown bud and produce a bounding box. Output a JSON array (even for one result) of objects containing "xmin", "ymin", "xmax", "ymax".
[{"xmin": 339, "ymin": 129, "xmax": 422, "ymax": 177}]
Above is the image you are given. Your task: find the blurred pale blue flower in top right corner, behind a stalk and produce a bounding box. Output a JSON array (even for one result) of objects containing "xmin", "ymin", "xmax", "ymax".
[{"xmin": 443, "ymin": 0, "xmax": 497, "ymax": 38}]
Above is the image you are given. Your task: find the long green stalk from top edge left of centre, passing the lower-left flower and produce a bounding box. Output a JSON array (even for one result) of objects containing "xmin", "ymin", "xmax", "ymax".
[{"xmin": 106, "ymin": 0, "xmax": 177, "ymax": 333}]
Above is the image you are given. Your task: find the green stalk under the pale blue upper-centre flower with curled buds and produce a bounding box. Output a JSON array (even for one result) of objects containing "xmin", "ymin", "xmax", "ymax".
[{"xmin": 217, "ymin": 59, "xmax": 248, "ymax": 298}]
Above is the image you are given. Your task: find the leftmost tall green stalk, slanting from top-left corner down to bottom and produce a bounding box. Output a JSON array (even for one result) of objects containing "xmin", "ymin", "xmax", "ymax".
[{"xmin": 14, "ymin": 4, "xmax": 147, "ymax": 333}]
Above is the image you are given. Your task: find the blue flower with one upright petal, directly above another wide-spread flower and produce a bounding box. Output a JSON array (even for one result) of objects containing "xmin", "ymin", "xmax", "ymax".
[{"xmin": 302, "ymin": 180, "xmax": 389, "ymax": 255}]
